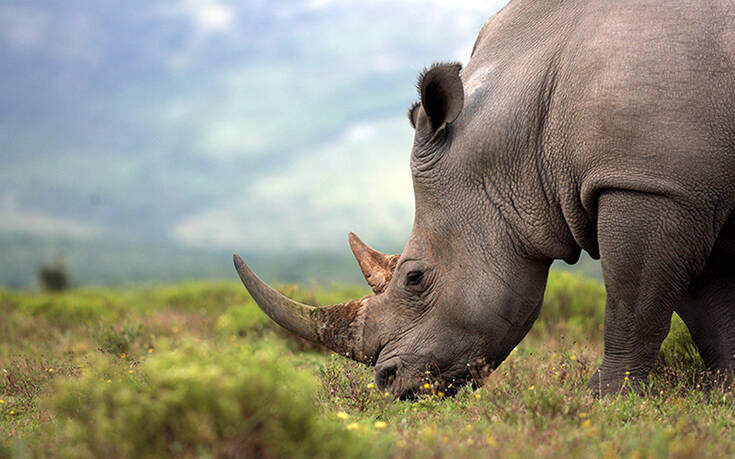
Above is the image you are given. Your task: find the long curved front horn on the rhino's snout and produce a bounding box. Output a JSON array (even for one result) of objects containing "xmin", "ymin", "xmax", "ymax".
[{"xmin": 233, "ymin": 255, "xmax": 376, "ymax": 365}]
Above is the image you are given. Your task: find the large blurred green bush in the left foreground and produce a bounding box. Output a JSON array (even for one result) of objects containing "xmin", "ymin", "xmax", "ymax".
[{"xmin": 38, "ymin": 340, "xmax": 388, "ymax": 458}]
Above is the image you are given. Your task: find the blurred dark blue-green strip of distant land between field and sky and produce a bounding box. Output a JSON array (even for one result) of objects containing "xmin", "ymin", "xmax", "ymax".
[{"xmin": 0, "ymin": 234, "xmax": 601, "ymax": 288}]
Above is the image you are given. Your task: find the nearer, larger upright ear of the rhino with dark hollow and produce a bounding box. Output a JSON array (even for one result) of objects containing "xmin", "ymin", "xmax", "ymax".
[{"xmin": 418, "ymin": 63, "xmax": 464, "ymax": 134}]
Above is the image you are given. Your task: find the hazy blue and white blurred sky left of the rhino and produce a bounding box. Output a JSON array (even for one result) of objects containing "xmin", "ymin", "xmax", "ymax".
[{"xmin": 0, "ymin": 0, "xmax": 505, "ymax": 255}]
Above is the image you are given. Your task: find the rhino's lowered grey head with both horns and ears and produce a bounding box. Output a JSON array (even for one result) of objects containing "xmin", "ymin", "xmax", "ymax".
[{"xmin": 235, "ymin": 64, "xmax": 550, "ymax": 397}]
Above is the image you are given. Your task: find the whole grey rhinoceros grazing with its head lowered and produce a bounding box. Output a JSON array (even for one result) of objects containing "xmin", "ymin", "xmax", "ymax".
[{"xmin": 234, "ymin": 0, "xmax": 735, "ymax": 397}]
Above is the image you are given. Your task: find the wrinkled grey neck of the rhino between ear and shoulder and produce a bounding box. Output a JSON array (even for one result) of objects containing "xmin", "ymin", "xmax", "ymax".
[{"xmin": 462, "ymin": 0, "xmax": 597, "ymax": 263}]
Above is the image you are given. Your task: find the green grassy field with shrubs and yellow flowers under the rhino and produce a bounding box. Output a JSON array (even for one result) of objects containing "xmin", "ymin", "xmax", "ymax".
[{"xmin": 0, "ymin": 272, "xmax": 735, "ymax": 458}]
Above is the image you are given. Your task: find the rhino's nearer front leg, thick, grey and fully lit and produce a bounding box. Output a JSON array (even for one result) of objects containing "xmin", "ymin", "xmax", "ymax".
[{"xmin": 589, "ymin": 190, "xmax": 714, "ymax": 395}]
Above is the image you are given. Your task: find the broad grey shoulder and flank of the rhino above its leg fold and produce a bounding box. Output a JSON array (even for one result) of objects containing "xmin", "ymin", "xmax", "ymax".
[{"xmin": 550, "ymin": 1, "xmax": 735, "ymax": 203}]
